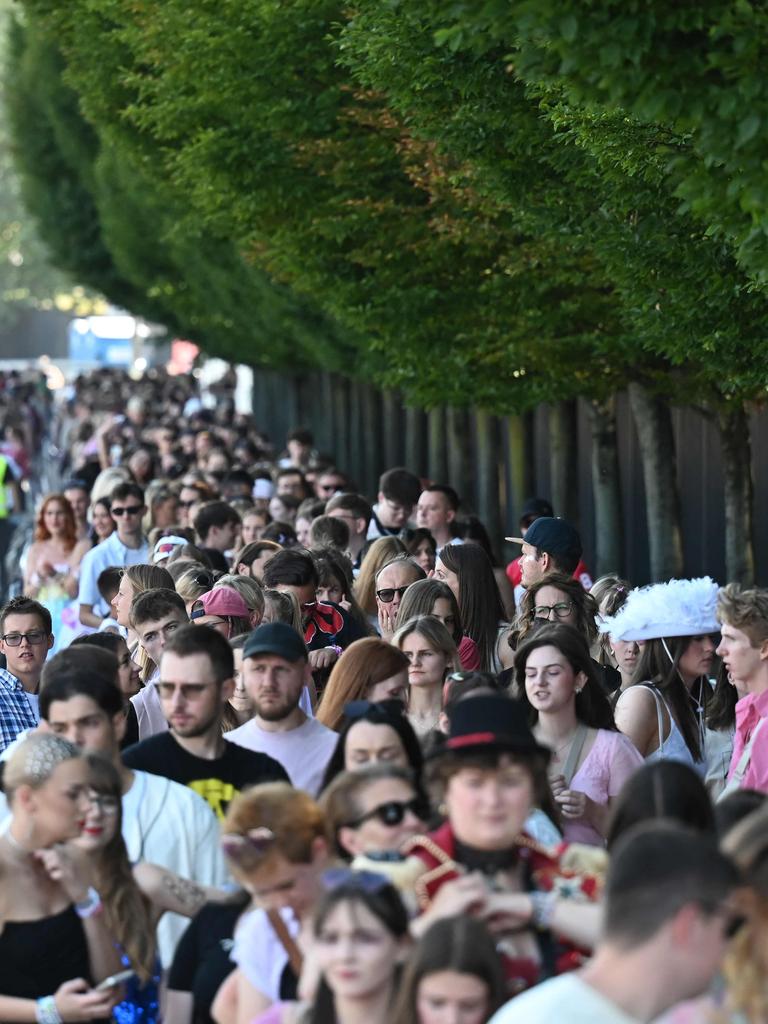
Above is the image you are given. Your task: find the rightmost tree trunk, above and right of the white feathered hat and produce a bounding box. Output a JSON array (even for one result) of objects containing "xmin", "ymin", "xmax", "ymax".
[{"xmin": 718, "ymin": 404, "xmax": 755, "ymax": 585}]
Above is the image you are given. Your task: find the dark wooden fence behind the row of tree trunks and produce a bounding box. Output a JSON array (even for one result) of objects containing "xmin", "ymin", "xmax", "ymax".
[{"xmin": 254, "ymin": 372, "xmax": 768, "ymax": 584}]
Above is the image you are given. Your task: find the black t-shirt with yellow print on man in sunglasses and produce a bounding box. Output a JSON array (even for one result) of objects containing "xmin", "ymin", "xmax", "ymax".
[{"xmin": 123, "ymin": 732, "xmax": 290, "ymax": 818}]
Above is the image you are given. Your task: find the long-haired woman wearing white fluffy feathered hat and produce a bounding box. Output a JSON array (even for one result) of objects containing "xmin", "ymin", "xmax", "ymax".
[{"xmin": 600, "ymin": 577, "xmax": 720, "ymax": 773}]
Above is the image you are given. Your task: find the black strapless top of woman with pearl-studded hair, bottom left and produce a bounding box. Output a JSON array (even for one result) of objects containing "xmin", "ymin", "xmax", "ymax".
[{"xmin": 0, "ymin": 906, "xmax": 90, "ymax": 999}]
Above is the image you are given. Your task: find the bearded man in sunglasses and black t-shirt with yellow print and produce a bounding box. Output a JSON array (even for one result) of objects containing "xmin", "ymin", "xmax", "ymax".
[{"xmin": 123, "ymin": 626, "xmax": 289, "ymax": 818}]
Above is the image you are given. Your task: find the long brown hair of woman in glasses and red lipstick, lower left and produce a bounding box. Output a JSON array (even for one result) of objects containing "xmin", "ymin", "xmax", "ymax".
[{"xmin": 86, "ymin": 754, "xmax": 157, "ymax": 984}]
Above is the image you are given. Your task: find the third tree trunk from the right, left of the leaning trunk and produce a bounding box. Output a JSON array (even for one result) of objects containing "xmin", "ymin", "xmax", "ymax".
[{"xmin": 588, "ymin": 395, "xmax": 624, "ymax": 577}]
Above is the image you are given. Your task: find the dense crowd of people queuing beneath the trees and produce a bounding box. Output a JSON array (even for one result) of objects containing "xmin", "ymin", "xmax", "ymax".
[{"xmin": 0, "ymin": 372, "xmax": 768, "ymax": 1024}]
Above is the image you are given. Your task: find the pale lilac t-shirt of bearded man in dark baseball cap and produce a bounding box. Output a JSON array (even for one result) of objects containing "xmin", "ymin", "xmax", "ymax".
[{"xmin": 224, "ymin": 718, "xmax": 339, "ymax": 797}]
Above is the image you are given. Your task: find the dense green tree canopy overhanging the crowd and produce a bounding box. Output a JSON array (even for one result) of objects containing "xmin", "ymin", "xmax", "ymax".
[{"xmin": 12, "ymin": 0, "xmax": 768, "ymax": 412}]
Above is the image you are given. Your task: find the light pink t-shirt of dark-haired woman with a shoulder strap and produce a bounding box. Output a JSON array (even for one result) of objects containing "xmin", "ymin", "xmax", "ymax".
[{"xmin": 562, "ymin": 729, "xmax": 645, "ymax": 846}]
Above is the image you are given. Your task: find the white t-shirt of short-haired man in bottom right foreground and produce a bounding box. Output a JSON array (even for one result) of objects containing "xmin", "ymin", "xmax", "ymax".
[{"xmin": 490, "ymin": 974, "xmax": 640, "ymax": 1024}]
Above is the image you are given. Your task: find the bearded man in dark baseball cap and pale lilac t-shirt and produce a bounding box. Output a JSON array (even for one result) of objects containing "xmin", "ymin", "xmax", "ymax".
[{"xmin": 225, "ymin": 623, "xmax": 338, "ymax": 796}]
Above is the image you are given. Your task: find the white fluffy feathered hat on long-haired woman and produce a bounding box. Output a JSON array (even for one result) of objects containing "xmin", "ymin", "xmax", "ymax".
[{"xmin": 599, "ymin": 577, "xmax": 720, "ymax": 640}]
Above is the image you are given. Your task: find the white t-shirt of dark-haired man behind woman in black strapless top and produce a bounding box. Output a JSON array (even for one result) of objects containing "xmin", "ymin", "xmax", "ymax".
[{"xmin": 123, "ymin": 771, "xmax": 230, "ymax": 968}]
